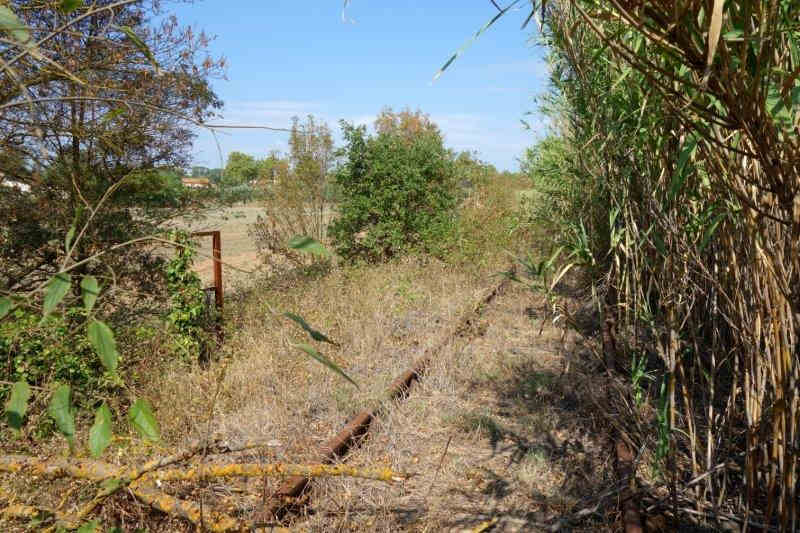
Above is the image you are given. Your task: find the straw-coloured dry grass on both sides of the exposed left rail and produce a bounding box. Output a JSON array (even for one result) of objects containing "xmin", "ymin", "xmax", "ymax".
[{"xmin": 136, "ymin": 270, "xmax": 613, "ymax": 531}]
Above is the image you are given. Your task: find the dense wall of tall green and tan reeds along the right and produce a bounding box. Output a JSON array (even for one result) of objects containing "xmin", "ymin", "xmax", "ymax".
[{"xmin": 528, "ymin": 0, "xmax": 800, "ymax": 531}]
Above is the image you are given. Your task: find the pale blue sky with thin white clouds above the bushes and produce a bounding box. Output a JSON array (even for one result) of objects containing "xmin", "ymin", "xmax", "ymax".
[{"xmin": 171, "ymin": 0, "xmax": 547, "ymax": 170}]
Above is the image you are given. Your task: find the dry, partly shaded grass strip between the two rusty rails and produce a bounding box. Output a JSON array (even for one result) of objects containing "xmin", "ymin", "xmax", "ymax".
[{"xmin": 302, "ymin": 284, "xmax": 613, "ymax": 531}]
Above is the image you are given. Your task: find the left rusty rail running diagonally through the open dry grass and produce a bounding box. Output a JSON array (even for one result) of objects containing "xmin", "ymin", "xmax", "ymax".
[{"xmin": 264, "ymin": 267, "xmax": 513, "ymax": 523}]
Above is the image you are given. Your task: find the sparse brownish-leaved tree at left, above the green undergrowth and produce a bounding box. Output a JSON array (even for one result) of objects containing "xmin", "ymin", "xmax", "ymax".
[{"xmin": 0, "ymin": 0, "xmax": 223, "ymax": 290}]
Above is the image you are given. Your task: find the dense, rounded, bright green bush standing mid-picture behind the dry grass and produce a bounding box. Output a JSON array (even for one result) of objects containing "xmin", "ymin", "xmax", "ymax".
[{"xmin": 329, "ymin": 122, "xmax": 457, "ymax": 261}]
